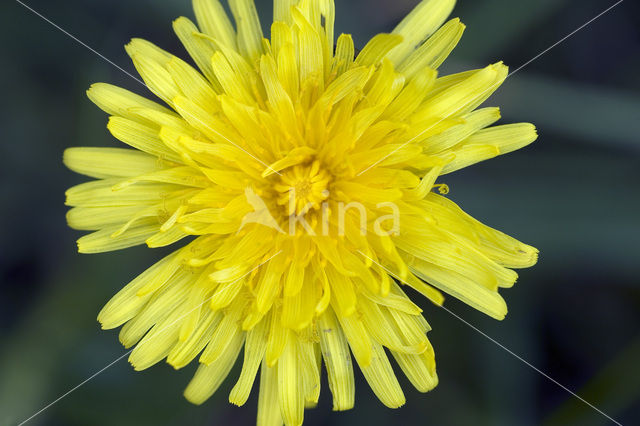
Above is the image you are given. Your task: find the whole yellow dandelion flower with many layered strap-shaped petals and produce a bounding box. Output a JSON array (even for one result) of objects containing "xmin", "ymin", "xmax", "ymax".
[{"xmin": 64, "ymin": 0, "xmax": 537, "ymax": 426}]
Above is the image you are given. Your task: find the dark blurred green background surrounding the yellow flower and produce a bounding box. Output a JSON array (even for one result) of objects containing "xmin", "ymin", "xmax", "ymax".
[{"xmin": 0, "ymin": 0, "xmax": 640, "ymax": 425}]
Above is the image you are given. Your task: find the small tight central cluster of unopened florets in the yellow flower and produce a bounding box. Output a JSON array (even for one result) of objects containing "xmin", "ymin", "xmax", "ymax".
[{"xmin": 275, "ymin": 161, "xmax": 331, "ymax": 215}]
